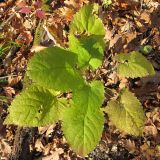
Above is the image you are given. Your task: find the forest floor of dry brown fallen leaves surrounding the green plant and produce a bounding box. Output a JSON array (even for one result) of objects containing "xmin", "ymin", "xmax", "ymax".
[{"xmin": 0, "ymin": 0, "xmax": 160, "ymax": 160}]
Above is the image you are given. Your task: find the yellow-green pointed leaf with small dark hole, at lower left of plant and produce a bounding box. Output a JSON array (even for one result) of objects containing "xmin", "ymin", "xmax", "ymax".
[{"xmin": 4, "ymin": 86, "xmax": 65, "ymax": 126}]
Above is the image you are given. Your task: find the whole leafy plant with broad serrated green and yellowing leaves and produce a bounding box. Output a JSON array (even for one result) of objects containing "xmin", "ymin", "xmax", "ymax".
[{"xmin": 5, "ymin": 5, "xmax": 154, "ymax": 156}]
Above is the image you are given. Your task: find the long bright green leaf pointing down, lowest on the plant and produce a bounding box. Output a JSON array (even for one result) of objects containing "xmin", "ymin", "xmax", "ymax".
[{"xmin": 62, "ymin": 81, "xmax": 104, "ymax": 156}]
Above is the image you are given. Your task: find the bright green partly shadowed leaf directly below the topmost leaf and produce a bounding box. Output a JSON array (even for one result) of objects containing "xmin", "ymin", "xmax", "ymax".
[{"xmin": 69, "ymin": 34, "xmax": 105, "ymax": 69}]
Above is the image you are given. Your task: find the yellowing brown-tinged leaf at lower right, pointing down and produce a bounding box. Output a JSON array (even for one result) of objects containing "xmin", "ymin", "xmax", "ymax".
[{"xmin": 105, "ymin": 89, "xmax": 145, "ymax": 136}]
